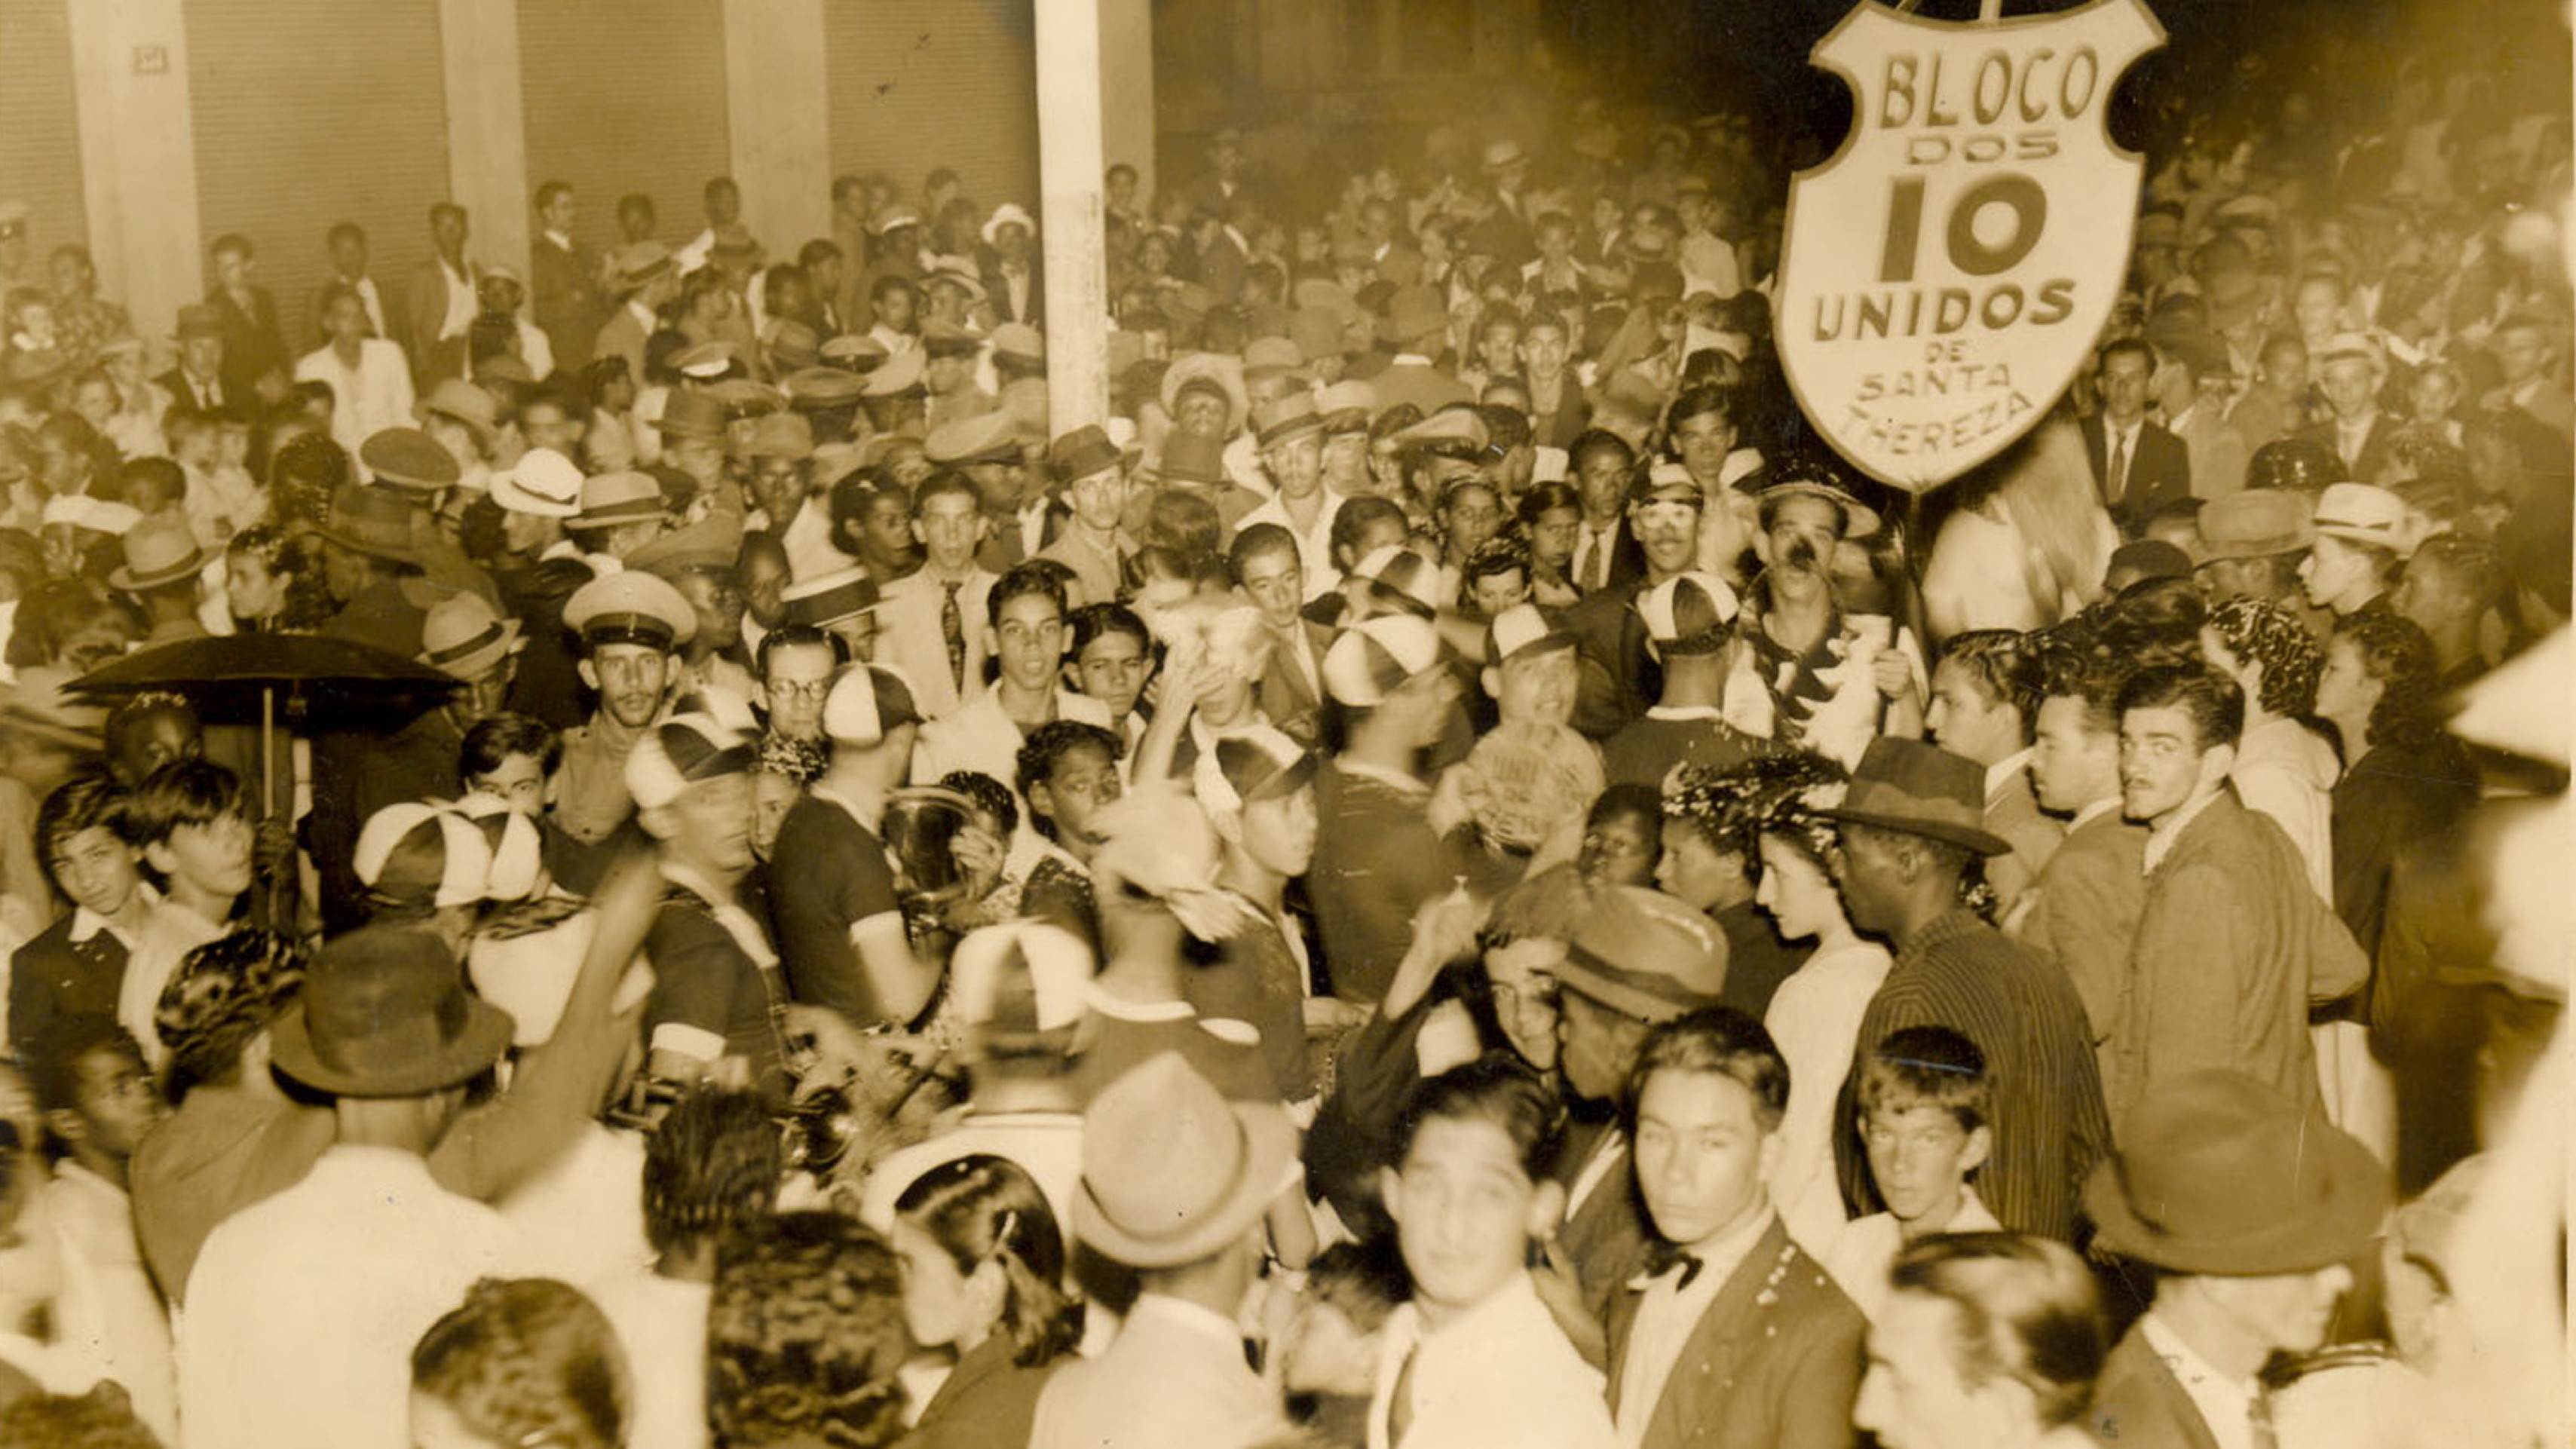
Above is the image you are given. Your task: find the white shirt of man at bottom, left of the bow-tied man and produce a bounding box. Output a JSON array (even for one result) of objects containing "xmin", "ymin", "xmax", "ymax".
[{"xmin": 1368, "ymin": 1273, "xmax": 1618, "ymax": 1449}]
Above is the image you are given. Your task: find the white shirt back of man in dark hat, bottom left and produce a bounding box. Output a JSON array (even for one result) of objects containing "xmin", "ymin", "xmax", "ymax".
[{"xmin": 178, "ymin": 1142, "xmax": 522, "ymax": 1449}]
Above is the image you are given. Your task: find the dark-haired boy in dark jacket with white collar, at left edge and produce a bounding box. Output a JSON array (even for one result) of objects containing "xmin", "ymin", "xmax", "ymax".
[{"xmin": 8, "ymin": 774, "xmax": 160, "ymax": 1062}]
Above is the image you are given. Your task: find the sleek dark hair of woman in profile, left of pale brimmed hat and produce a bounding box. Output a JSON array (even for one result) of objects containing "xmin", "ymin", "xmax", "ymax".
[{"xmin": 894, "ymin": 1153, "xmax": 1082, "ymax": 1369}]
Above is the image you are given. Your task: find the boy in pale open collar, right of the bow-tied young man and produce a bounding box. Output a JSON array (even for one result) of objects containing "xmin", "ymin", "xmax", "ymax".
[{"xmin": 1818, "ymin": 1026, "xmax": 2002, "ymax": 1320}]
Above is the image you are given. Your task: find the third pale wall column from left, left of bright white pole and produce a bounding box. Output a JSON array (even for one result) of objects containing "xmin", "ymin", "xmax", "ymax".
[{"xmin": 721, "ymin": 0, "xmax": 829, "ymax": 268}]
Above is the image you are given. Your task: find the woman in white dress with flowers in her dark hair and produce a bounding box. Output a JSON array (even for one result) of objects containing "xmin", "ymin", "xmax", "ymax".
[{"xmin": 1736, "ymin": 750, "xmax": 1888, "ymax": 1245}]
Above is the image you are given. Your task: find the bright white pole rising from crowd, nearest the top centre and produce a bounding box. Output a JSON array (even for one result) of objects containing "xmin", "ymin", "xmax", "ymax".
[{"xmin": 1038, "ymin": 0, "xmax": 1107, "ymax": 433}]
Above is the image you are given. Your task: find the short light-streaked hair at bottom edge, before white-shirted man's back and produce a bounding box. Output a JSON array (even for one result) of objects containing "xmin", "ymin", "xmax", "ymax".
[{"xmin": 412, "ymin": 1279, "xmax": 634, "ymax": 1449}]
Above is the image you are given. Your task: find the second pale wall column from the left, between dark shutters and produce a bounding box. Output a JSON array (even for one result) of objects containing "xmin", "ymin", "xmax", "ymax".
[{"xmin": 438, "ymin": 0, "xmax": 533, "ymax": 276}]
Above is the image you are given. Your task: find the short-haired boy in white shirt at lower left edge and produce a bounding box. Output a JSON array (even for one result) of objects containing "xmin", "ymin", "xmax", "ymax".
[{"xmin": 31, "ymin": 1016, "xmax": 178, "ymax": 1436}]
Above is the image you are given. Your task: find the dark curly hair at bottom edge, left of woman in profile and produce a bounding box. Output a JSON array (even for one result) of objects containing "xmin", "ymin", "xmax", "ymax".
[{"xmin": 706, "ymin": 1212, "xmax": 909, "ymax": 1449}]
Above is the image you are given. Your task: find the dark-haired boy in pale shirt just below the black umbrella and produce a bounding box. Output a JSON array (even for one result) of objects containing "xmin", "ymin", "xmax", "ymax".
[{"xmin": 116, "ymin": 761, "xmax": 255, "ymax": 1070}]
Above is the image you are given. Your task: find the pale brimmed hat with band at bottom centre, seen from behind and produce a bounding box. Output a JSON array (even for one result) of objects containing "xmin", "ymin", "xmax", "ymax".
[{"xmin": 1071, "ymin": 1052, "xmax": 1296, "ymax": 1269}]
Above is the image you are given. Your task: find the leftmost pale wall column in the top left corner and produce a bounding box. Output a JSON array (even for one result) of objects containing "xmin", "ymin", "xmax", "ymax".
[{"xmin": 64, "ymin": 0, "xmax": 206, "ymax": 345}]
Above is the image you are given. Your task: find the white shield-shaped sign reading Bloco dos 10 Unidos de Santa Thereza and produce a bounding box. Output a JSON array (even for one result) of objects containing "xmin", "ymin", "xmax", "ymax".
[{"xmin": 1772, "ymin": 0, "xmax": 2164, "ymax": 492}]
